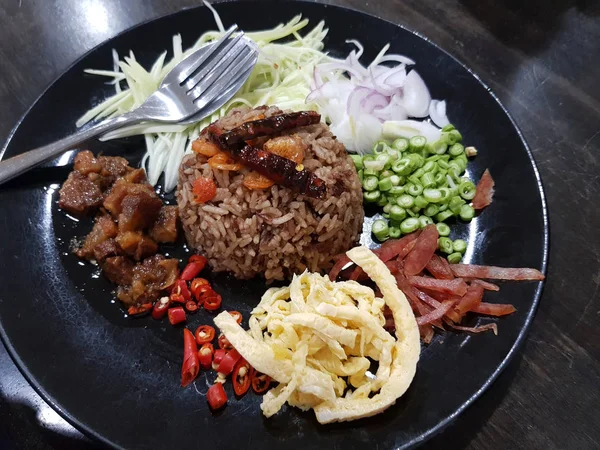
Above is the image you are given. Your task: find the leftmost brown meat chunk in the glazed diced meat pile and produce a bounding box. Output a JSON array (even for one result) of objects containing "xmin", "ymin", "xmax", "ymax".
[{"xmin": 58, "ymin": 170, "xmax": 103, "ymax": 215}]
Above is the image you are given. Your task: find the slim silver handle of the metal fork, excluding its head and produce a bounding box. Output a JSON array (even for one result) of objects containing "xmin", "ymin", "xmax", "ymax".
[{"xmin": 0, "ymin": 113, "xmax": 141, "ymax": 184}]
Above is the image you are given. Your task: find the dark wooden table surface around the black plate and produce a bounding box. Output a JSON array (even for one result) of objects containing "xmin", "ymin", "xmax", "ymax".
[{"xmin": 0, "ymin": 0, "xmax": 600, "ymax": 450}]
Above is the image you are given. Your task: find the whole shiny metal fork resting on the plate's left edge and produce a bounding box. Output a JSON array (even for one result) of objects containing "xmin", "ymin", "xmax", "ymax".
[{"xmin": 0, "ymin": 25, "xmax": 258, "ymax": 184}]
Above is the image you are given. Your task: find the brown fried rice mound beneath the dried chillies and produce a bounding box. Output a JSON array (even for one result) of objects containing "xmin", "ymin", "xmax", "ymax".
[{"xmin": 177, "ymin": 107, "xmax": 364, "ymax": 280}]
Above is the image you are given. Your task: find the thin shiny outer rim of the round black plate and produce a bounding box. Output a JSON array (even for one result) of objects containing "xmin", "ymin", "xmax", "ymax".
[{"xmin": 0, "ymin": 0, "xmax": 550, "ymax": 450}]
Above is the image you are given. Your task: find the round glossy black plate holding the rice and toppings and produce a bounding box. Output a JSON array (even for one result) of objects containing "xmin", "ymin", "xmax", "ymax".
[{"xmin": 0, "ymin": 1, "xmax": 548, "ymax": 449}]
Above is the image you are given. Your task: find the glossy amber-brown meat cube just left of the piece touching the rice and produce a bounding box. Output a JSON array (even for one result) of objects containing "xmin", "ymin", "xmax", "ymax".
[{"xmin": 118, "ymin": 192, "xmax": 163, "ymax": 232}]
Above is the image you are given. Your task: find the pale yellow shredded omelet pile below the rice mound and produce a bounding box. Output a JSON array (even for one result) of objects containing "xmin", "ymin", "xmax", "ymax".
[{"xmin": 215, "ymin": 247, "xmax": 420, "ymax": 423}]
